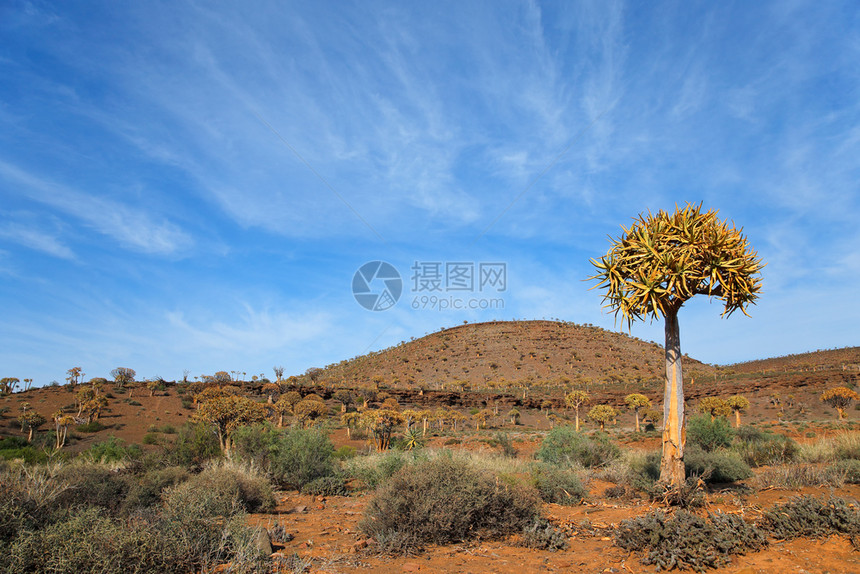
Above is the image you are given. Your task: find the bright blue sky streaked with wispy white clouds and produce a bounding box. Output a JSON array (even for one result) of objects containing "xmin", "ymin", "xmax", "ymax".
[{"xmin": 0, "ymin": 0, "xmax": 860, "ymax": 384}]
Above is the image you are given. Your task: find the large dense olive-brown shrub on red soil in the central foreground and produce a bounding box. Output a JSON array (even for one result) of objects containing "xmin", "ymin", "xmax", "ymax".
[{"xmin": 359, "ymin": 457, "xmax": 538, "ymax": 552}]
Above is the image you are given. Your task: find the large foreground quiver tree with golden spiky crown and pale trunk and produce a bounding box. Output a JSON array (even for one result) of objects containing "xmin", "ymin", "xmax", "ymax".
[{"xmin": 590, "ymin": 203, "xmax": 764, "ymax": 488}]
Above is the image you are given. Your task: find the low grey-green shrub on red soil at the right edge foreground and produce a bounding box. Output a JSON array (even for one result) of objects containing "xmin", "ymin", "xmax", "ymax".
[{"xmin": 761, "ymin": 496, "xmax": 860, "ymax": 539}]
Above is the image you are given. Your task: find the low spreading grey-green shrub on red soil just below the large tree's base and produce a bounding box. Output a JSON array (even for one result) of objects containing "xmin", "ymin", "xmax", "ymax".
[{"xmin": 615, "ymin": 510, "xmax": 767, "ymax": 572}]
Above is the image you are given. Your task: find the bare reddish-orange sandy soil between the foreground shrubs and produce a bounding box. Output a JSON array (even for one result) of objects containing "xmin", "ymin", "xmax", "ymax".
[{"xmin": 251, "ymin": 483, "xmax": 860, "ymax": 574}]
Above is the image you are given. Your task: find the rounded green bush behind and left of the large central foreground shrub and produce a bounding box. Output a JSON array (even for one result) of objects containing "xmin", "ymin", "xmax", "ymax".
[{"xmin": 269, "ymin": 428, "xmax": 335, "ymax": 490}]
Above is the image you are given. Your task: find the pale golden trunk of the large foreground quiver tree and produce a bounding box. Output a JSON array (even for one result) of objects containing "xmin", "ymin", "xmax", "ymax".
[{"xmin": 660, "ymin": 310, "xmax": 687, "ymax": 487}]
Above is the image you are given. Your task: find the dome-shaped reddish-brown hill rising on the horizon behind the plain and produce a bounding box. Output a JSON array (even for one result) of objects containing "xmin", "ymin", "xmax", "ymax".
[{"xmin": 317, "ymin": 321, "xmax": 718, "ymax": 389}]
